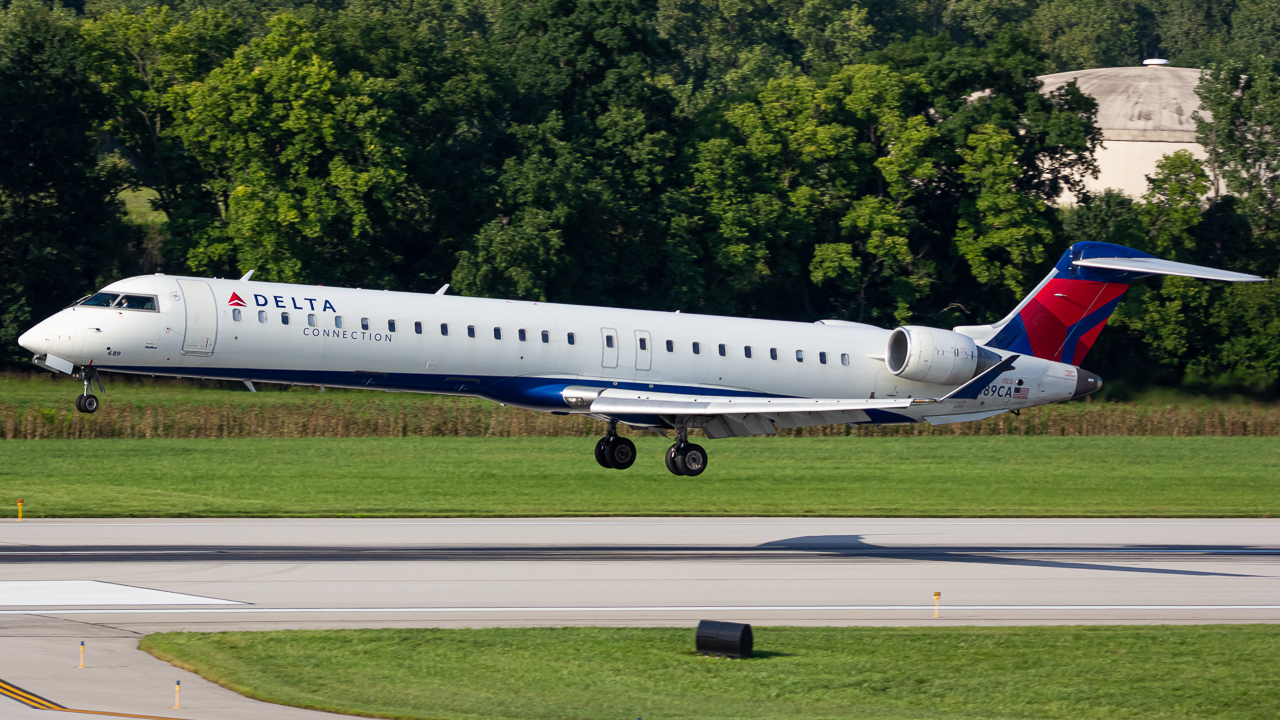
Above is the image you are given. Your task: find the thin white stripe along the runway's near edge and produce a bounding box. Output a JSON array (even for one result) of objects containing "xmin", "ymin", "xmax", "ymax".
[{"xmin": 0, "ymin": 605, "xmax": 1280, "ymax": 615}]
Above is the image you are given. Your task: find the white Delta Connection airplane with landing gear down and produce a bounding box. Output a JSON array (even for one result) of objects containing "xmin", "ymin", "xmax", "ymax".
[{"xmin": 18, "ymin": 242, "xmax": 1266, "ymax": 475}]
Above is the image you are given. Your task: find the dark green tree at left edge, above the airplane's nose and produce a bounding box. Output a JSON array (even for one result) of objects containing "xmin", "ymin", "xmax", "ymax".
[{"xmin": 0, "ymin": 0, "xmax": 136, "ymax": 360}]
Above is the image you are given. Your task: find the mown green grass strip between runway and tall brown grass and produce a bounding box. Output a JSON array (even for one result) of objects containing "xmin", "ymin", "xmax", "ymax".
[{"xmin": 0, "ymin": 437, "xmax": 1280, "ymax": 518}]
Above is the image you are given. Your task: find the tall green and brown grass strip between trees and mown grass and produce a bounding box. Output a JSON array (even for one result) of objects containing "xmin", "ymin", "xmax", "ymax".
[{"xmin": 0, "ymin": 373, "xmax": 1280, "ymax": 439}]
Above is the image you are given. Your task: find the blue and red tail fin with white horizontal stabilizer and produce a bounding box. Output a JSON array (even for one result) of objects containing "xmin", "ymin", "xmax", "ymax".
[{"xmin": 955, "ymin": 242, "xmax": 1266, "ymax": 365}]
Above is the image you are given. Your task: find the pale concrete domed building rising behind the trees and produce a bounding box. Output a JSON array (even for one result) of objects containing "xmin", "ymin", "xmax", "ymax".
[{"xmin": 1039, "ymin": 60, "xmax": 1207, "ymax": 202}]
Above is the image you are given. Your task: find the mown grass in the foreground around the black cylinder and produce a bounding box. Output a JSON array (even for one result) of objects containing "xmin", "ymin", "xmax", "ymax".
[{"xmin": 142, "ymin": 625, "xmax": 1280, "ymax": 720}]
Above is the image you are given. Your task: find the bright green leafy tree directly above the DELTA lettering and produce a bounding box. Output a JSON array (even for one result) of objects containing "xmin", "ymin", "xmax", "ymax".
[{"xmin": 169, "ymin": 15, "xmax": 404, "ymax": 284}]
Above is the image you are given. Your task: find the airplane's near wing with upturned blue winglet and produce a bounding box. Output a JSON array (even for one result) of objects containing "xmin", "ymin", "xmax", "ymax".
[{"xmin": 563, "ymin": 355, "xmax": 1019, "ymax": 438}]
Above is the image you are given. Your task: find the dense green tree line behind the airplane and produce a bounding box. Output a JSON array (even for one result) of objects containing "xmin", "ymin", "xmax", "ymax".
[{"xmin": 0, "ymin": 0, "xmax": 1280, "ymax": 393}]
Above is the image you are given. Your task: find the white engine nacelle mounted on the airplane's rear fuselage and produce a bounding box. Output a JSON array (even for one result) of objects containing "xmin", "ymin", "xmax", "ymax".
[{"xmin": 884, "ymin": 325, "xmax": 1000, "ymax": 386}]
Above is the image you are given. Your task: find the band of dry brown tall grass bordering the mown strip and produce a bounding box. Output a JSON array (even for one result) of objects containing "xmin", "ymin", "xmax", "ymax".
[{"xmin": 0, "ymin": 398, "xmax": 1280, "ymax": 439}]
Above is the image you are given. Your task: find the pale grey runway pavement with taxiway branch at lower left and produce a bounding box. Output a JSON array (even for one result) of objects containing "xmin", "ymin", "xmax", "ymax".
[{"xmin": 0, "ymin": 518, "xmax": 1280, "ymax": 719}]
